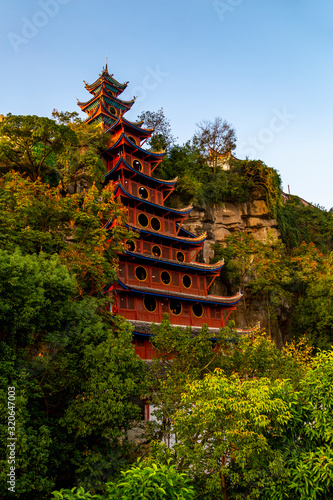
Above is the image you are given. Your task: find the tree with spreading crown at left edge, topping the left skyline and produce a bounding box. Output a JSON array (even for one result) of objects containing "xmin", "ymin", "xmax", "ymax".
[{"xmin": 0, "ymin": 114, "xmax": 77, "ymax": 185}]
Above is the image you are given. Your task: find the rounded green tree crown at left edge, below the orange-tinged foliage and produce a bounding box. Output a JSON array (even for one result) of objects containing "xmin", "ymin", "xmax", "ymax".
[{"xmin": 0, "ymin": 250, "xmax": 76, "ymax": 348}]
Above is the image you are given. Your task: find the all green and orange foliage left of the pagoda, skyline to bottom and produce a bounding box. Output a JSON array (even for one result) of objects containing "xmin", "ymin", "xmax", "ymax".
[{"xmin": 0, "ymin": 113, "xmax": 144, "ymax": 500}]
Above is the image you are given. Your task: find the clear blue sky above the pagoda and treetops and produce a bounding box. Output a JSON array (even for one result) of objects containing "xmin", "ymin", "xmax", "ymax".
[{"xmin": 0, "ymin": 0, "xmax": 333, "ymax": 209}]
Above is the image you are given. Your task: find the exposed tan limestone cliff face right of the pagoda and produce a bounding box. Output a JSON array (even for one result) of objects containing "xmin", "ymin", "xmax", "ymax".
[{"xmin": 184, "ymin": 199, "xmax": 283, "ymax": 344}]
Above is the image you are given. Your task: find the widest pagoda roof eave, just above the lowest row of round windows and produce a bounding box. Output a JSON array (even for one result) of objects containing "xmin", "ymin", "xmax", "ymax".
[{"xmin": 113, "ymin": 278, "xmax": 243, "ymax": 306}]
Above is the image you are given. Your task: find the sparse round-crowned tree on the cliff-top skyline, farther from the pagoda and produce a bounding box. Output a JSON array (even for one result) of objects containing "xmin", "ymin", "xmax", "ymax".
[{"xmin": 193, "ymin": 116, "xmax": 236, "ymax": 173}]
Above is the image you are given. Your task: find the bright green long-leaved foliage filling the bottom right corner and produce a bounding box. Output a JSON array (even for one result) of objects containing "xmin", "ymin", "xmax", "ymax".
[{"xmin": 267, "ymin": 351, "xmax": 333, "ymax": 500}]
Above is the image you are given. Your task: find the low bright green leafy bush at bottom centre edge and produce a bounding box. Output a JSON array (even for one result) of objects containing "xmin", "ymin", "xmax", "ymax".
[{"xmin": 106, "ymin": 461, "xmax": 195, "ymax": 500}]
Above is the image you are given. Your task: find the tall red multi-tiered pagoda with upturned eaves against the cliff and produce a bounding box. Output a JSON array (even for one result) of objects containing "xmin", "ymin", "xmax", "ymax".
[{"xmin": 78, "ymin": 66, "xmax": 241, "ymax": 359}]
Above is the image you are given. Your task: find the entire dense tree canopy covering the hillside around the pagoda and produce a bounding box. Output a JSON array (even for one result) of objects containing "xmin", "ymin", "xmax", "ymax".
[{"xmin": 0, "ymin": 109, "xmax": 333, "ymax": 500}]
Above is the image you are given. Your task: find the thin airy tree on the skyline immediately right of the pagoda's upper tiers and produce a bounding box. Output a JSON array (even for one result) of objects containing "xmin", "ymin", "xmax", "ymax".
[{"xmin": 138, "ymin": 108, "xmax": 175, "ymax": 151}]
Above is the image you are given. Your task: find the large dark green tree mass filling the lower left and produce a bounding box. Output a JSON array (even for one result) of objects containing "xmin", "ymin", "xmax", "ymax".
[{"xmin": 0, "ymin": 250, "xmax": 144, "ymax": 500}]
